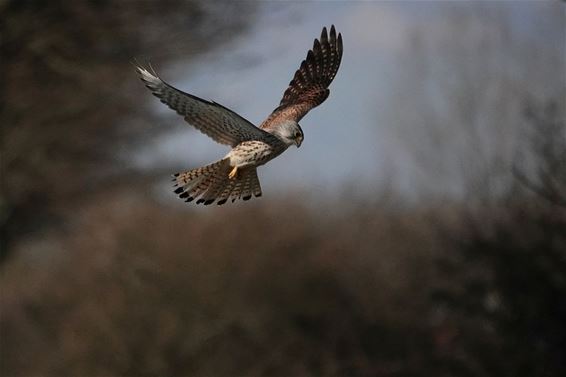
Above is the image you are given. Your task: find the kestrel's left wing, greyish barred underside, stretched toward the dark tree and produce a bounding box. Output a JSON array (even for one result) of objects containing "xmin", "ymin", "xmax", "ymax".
[{"xmin": 136, "ymin": 66, "xmax": 271, "ymax": 147}]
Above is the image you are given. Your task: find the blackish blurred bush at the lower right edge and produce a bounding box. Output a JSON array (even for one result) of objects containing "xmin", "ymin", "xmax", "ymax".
[{"xmin": 437, "ymin": 101, "xmax": 566, "ymax": 376}]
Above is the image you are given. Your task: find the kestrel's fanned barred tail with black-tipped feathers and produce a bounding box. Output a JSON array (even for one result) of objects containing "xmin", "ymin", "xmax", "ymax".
[{"xmin": 173, "ymin": 159, "xmax": 261, "ymax": 205}]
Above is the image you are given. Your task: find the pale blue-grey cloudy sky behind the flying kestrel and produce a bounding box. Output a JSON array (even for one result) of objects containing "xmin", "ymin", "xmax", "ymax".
[{"xmin": 134, "ymin": 2, "xmax": 564, "ymax": 200}]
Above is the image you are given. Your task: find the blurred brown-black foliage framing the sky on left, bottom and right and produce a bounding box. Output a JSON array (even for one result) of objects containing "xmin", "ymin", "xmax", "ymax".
[{"xmin": 0, "ymin": 1, "xmax": 566, "ymax": 377}]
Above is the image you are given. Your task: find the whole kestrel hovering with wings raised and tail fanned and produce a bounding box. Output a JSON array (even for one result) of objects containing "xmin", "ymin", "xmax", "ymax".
[{"xmin": 136, "ymin": 25, "xmax": 342, "ymax": 205}]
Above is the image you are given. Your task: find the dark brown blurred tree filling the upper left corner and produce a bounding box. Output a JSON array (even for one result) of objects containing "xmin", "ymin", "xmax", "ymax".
[{"xmin": 0, "ymin": 0, "xmax": 253, "ymax": 259}]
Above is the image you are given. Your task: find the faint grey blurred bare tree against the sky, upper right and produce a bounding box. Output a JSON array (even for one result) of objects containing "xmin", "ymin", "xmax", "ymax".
[{"xmin": 389, "ymin": 2, "xmax": 566, "ymax": 200}]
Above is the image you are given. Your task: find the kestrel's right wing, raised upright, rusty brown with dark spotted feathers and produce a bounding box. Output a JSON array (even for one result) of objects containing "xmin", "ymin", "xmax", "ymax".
[{"xmin": 260, "ymin": 25, "xmax": 343, "ymax": 129}]
